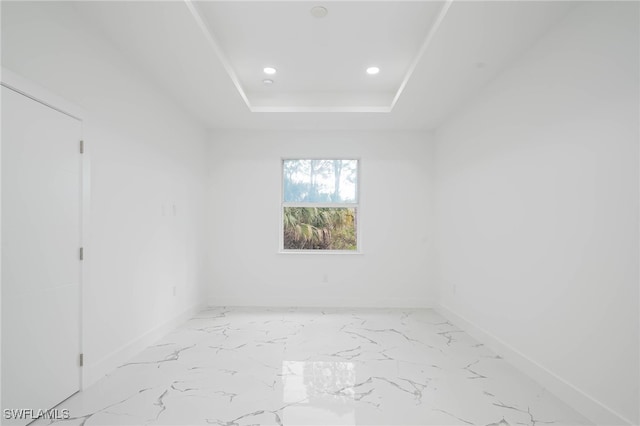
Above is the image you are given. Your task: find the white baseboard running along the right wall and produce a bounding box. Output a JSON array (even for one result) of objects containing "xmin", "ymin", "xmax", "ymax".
[{"xmin": 435, "ymin": 304, "xmax": 634, "ymax": 425}]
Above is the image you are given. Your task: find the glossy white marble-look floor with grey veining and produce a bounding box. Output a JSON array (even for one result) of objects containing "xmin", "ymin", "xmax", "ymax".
[{"xmin": 41, "ymin": 308, "xmax": 590, "ymax": 426}]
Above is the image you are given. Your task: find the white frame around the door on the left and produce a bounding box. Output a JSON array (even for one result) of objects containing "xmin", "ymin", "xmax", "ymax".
[{"xmin": 0, "ymin": 67, "xmax": 91, "ymax": 397}]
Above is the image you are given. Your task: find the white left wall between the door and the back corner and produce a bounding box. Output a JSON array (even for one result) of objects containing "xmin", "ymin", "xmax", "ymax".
[{"xmin": 2, "ymin": 2, "xmax": 206, "ymax": 383}]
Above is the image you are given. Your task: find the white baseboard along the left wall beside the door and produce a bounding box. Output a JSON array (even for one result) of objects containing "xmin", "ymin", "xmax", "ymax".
[{"xmin": 82, "ymin": 304, "xmax": 206, "ymax": 389}]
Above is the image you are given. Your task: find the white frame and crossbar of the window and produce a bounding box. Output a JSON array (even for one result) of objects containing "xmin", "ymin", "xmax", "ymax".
[{"xmin": 278, "ymin": 156, "xmax": 362, "ymax": 255}]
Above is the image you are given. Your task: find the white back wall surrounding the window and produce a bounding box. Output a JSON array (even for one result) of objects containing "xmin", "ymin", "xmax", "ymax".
[{"xmin": 208, "ymin": 131, "xmax": 434, "ymax": 307}]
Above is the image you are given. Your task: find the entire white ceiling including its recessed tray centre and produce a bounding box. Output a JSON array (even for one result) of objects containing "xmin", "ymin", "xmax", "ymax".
[{"xmin": 76, "ymin": 0, "xmax": 576, "ymax": 130}]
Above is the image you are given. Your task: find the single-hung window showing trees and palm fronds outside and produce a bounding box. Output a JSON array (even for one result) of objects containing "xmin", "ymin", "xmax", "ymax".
[{"xmin": 281, "ymin": 159, "xmax": 358, "ymax": 252}]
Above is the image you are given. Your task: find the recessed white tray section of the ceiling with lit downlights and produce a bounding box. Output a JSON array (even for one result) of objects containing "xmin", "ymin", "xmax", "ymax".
[{"xmin": 192, "ymin": 1, "xmax": 445, "ymax": 112}]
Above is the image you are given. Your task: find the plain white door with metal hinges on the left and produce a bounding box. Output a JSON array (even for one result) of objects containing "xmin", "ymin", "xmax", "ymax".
[{"xmin": 1, "ymin": 87, "xmax": 82, "ymax": 424}]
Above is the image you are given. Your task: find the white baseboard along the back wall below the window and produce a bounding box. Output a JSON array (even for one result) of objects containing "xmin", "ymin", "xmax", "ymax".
[{"xmin": 208, "ymin": 297, "xmax": 436, "ymax": 309}]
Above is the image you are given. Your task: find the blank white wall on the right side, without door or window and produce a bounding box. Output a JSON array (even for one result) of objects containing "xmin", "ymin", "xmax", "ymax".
[{"xmin": 435, "ymin": 2, "xmax": 640, "ymax": 424}]
